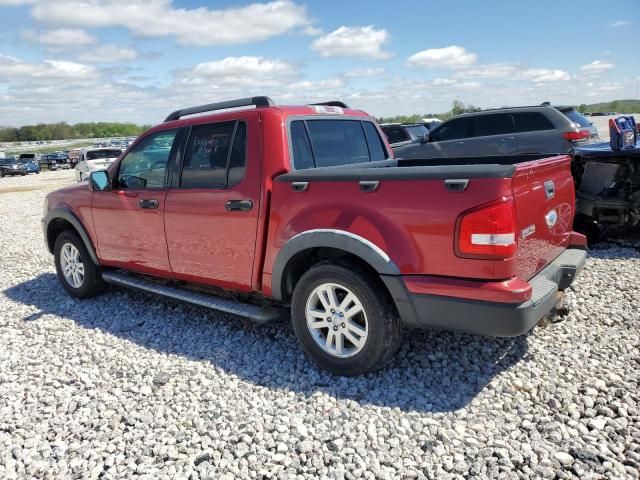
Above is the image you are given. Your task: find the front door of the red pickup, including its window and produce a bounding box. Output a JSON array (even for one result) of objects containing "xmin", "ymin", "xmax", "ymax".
[{"xmin": 92, "ymin": 129, "xmax": 178, "ymax": 276}]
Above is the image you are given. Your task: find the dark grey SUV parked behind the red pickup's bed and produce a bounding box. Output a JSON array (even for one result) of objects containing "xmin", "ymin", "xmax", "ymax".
[{"xmin": 394, "ymin": 105, "xmax": 598, "ymax": 158}]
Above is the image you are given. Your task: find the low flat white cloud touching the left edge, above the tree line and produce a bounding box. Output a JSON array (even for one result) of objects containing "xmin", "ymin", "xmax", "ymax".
[{"xmin": 0, "ymin": 55, "xmax": 95, "ymax": 80}]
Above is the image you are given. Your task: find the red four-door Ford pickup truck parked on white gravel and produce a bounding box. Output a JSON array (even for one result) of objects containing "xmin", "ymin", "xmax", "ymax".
[{"xmin": 43, "ymin": 97, "xmax": 586, "ymax": 375}]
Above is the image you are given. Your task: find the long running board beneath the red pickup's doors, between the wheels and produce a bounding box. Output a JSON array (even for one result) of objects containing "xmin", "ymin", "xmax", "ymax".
[{"xmin": 102, "ymin": 271, "xmax": 283, "ymax": 323}]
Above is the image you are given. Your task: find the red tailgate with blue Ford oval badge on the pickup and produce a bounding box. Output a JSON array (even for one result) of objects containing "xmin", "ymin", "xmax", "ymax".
[{"xmin": 512, "ymin": 155, "xmax": 575, "ymax": 280}]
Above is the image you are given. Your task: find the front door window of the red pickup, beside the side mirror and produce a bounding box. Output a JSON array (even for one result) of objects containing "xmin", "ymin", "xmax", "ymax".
[{"xmin": 118, "ymin": 129, "xmax": 178, "ymax": 188}]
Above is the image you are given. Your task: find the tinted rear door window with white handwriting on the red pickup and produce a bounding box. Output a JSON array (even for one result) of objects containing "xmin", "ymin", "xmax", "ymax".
[{"xmin": 180, "ymin": 121, "xmax": 246, "ymax": 188}]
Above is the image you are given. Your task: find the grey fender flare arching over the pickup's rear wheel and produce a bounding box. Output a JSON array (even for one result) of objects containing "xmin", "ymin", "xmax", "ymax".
[{"xmin": 271, "ymin": 229, "xmax": 400, "ymax": 300}]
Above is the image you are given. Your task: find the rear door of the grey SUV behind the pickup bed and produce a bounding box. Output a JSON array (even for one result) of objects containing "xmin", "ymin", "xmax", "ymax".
[{"xmin": 467, "ymin": 113, "xmax": 517, "ymax": 156}]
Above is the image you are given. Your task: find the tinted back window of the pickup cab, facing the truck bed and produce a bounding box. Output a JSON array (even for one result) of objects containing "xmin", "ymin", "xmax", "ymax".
[{"xmin": 290, "ymin": 120, "xmax": 387, "ymax": 170}]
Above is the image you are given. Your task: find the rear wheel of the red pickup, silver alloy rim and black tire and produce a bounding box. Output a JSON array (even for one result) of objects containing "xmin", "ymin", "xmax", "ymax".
[{"xmin": 291, "ymin": 262, "xmax": 402, "ymax": 377}]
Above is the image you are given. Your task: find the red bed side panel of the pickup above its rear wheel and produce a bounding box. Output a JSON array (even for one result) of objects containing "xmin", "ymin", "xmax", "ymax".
[{"xmin": 264, "ymin": 178, "xmax": 514, "ymax": 286}]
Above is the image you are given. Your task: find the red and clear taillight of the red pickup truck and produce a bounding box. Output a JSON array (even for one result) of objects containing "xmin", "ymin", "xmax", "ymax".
[{"xmin": 456, "ymin": 199, "xmax": 518, "ymax": 259}]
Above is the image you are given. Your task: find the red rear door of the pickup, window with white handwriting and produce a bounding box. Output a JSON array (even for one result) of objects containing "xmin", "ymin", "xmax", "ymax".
[{"xmin": 165, "ymin": 112, "xmax": 260, "ymax": 291}]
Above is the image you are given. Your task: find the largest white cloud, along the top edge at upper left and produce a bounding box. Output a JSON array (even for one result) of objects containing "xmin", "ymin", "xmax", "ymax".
[{"xmin": 26, "ymin": 0, "xmax": 311, "ymax": 46}]
